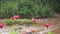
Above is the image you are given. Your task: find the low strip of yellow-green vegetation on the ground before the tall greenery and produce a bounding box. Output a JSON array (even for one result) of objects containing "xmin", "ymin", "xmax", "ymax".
[{"xmin": 3, "ymin": 19, "xmax": 40, "ymax": 25}]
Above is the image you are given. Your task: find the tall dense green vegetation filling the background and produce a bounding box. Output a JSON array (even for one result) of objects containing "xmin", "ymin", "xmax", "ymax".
[{"xmin": 0, "ymin": 0, "xmax": 60, "ymax": 18}]
